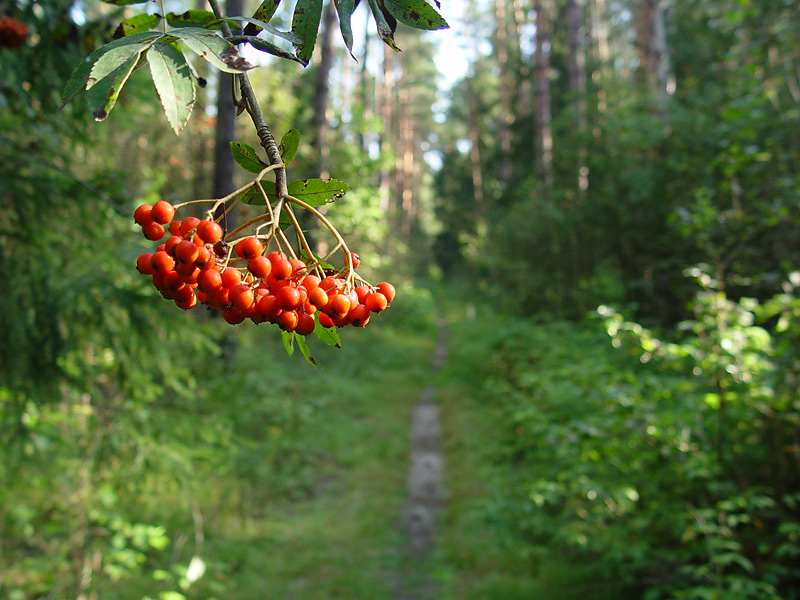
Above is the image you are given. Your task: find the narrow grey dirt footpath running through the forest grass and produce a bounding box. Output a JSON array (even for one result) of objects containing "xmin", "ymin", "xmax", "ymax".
[{"xmin": 395, "ymin": 317, "xmax": 447, "ymax": 600}]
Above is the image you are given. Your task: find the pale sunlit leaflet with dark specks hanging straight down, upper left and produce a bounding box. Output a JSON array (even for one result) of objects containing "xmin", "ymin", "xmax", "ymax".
[{"xmin": 147, "ymin": 44, "xmax": 195, "ymax": 135}]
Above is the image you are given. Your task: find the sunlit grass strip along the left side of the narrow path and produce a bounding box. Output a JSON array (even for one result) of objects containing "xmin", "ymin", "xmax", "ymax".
[{"xmin": 191, "ymin": 286, "xmax": 444, "ymax": 600}]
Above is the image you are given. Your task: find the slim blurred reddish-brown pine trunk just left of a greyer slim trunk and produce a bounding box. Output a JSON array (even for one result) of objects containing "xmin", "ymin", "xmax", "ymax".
[{"xmin": 533, "ymin": 0, "xmax": 553, "ymax": 192}]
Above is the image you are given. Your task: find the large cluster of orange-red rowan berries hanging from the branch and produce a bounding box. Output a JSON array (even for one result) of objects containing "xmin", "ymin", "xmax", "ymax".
[{"xmin": 134, "ymin": 200, "xmax": 395, "ymax": 335}]
